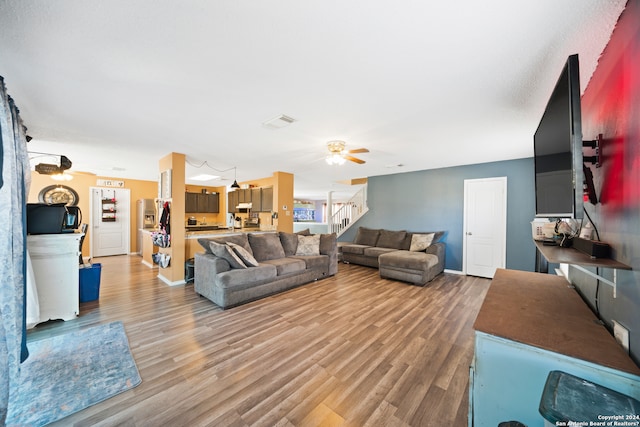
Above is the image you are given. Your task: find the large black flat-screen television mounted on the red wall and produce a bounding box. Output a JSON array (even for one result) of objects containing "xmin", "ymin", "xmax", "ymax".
[{"xmin": 533, "ymin": 55, "xmax": 584, "ymax": 219}]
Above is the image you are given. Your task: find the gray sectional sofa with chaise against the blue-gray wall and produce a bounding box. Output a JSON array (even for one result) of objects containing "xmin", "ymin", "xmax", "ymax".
[{"xmin": 340, "ymin": 227, "xmax": 445, "ymax": 286}]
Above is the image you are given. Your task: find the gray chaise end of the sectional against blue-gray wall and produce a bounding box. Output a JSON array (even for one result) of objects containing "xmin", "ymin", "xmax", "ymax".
[{"xmin": 378, "ymin": 251, "xmax": 442, "ymax": 286}]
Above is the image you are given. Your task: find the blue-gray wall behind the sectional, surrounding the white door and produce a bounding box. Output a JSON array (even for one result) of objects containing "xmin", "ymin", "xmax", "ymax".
[{"xmin": 339, "ymin": 158, "xmax": 535, "ymax": 271}]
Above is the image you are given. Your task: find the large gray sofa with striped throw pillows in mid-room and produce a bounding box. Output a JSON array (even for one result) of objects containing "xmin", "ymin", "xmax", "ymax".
[{"xmin": 194, "ymin": 232, "xmax": 338, "ymax": 309}]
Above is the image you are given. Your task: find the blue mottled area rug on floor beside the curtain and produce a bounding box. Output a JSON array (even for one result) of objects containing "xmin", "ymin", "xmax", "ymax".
[{"xmin": 7, "ymin": 322, "xmax": 142, "ymax": 427}]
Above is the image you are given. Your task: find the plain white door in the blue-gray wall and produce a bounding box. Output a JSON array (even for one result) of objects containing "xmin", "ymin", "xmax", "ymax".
[{"xmin": 463, "ymin": 177, "xmax": 507, "ymax": 278}]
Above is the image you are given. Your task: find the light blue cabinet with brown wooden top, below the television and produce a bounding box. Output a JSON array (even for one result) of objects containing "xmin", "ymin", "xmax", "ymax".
[{"xmin": 469, "ymin": 269, "xmax": 640, "ymax": 427}]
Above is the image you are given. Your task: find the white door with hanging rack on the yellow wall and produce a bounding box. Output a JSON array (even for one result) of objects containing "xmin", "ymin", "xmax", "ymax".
[{"xmin": 90, "ymin": 187, "xmax": 131, "ymax": 257}]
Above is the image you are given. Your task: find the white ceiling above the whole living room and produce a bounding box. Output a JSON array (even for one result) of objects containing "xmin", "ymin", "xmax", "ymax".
[{"xmin": 0, "ymin": 0, "xmax": 625, "ymax": 199}]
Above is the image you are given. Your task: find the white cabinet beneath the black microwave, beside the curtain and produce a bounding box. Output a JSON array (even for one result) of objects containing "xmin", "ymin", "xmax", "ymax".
[{"xmin": 27, "ymin": 233, "xmax": 83, "ymax": 322}]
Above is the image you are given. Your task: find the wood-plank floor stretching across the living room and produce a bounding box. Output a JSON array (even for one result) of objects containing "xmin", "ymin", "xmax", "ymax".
[{"xmin": 28, "ymin": 256, "xmax": 490, "ymax": 426}]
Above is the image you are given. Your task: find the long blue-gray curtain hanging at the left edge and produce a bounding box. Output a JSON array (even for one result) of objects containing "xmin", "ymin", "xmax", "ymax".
[{"xmin": 0, "ymin": 76, "xmax": 31, "ymax": 425}]
